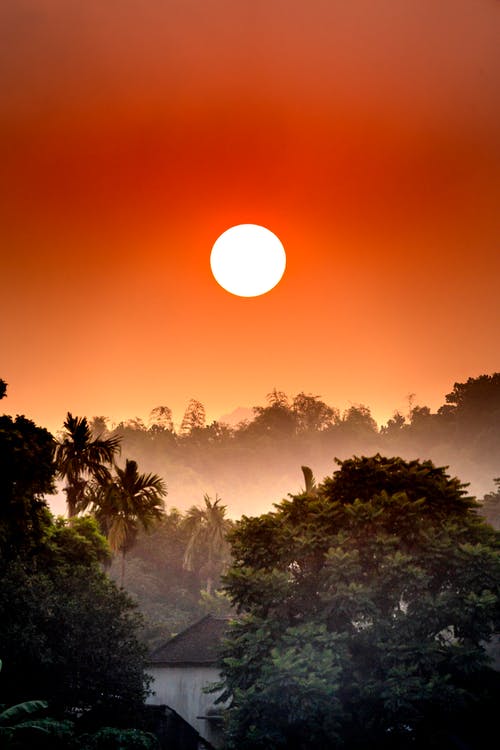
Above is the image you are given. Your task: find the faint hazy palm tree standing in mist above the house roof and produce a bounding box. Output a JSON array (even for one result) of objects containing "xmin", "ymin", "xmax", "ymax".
[{"xmin": 183, "ymin": 495, "xmax": 232, "ymax": 594}]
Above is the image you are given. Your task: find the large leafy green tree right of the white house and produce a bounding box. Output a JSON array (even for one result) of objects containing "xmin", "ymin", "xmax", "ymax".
[{"xmin": 221, "ymin": 455, "xmax": 500, "ymax": 750}]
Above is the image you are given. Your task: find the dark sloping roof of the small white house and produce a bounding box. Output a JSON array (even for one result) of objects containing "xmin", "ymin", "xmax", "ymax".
[{"xmin": 150, "ymin": 615, "xmax": 230, "ymax": 666}]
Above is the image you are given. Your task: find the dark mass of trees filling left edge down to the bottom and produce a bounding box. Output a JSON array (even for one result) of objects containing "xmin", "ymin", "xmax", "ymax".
[{"xmin": 0, "ymin": 406, "xmax": 158, "ymax": 749}]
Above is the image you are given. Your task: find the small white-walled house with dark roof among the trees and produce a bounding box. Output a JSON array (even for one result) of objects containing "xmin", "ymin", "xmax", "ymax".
[{"xmin": 147, "ymin": 615, "xmax": 229, "ymax": 747}]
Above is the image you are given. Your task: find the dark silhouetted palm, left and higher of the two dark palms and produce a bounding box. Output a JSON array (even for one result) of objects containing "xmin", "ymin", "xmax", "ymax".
[{"xmin": 55, "ymin": 412, "xmax": 121, "ymax": 518}]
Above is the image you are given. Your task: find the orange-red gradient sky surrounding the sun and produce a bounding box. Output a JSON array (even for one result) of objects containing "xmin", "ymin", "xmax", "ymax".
[{"xmin": 0, "ymin": 0, "xmax": 500, "ymax": 431}]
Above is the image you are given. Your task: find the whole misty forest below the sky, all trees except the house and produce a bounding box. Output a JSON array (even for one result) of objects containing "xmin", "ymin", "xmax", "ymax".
[{"xmin": 0, "ymin": 373, "xmax": 500, "ymax": 750}]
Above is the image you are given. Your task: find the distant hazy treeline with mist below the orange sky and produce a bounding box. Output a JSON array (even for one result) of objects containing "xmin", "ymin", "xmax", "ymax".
[{"xmin": 90, "ymin": 373, "xmax": 500, "ymax": 518}]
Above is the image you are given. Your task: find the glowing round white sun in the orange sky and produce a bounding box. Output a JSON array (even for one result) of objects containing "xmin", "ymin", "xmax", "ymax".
[{"xmin": 210, "ymin": 224, "xmax": 286, "ymax": 297}]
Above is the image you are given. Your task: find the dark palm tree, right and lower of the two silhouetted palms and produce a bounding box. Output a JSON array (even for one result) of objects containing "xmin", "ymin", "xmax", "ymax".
[{"xmin": 89, "ymin": 458, "xmax": 167, "ymax": 586}]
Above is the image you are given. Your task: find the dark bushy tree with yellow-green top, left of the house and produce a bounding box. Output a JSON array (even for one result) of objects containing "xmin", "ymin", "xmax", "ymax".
[{"xmin": 0, "ymin": 518, "xmax": 148, "ymax": 716}]
